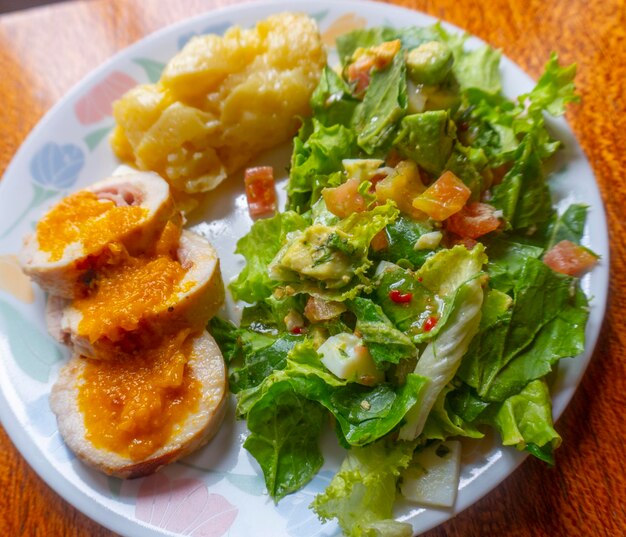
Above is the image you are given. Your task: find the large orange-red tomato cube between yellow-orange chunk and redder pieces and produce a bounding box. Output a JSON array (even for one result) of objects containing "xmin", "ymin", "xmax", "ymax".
[{"xmin": 413, "ymin": 171, "xmax": 471, "ymax": 222}]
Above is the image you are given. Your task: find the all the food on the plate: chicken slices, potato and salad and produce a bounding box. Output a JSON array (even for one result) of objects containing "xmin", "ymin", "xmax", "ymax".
[{"xmin": 17, "ymin": 13, "xmax": 597, "ymax": 536}]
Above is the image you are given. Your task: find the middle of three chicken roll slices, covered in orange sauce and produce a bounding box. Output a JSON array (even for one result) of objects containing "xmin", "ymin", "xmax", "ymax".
[{"xmin": 53, "ymin": 228, "xmax": 224, "ymax": 360}]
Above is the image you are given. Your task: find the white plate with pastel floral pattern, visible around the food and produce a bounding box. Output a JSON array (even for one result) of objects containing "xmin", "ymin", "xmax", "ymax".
[{"xmin": 0, "ymin": 0, "xmax": 609, "ymax": 537}]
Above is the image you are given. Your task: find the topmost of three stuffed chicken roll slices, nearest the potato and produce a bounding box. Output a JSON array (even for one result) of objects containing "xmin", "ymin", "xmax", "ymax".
[{"xmin": 20, "ymin": 172, "xmax": 176, "ymax": 298}]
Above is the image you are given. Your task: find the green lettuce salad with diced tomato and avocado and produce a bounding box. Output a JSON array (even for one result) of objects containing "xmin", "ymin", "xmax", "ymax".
[{"xmin": 210, "ymin": 25, "xmax": 596, "ymax": 536}]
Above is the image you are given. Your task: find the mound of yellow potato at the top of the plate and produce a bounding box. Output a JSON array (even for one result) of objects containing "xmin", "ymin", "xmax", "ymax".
[{"xmin": 111, "ymin": 13, "xmax": 326, "ymax": 199}]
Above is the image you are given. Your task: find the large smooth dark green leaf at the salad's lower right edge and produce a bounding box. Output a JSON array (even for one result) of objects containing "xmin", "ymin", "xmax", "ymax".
[{"xmin": 458, "ymin": 258, "xmax": 587, "ymax": 401}]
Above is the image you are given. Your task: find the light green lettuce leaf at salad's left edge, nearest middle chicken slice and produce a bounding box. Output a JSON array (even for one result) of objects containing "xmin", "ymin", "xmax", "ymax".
[{"xmin": 229, "ymin": 211, "xmax": 307, "ymax": 303}]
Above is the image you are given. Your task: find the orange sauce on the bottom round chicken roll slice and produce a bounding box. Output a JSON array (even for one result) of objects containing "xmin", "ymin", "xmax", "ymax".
[{"xmin": 78, "ymin": 330, "xmax": 201, "ymax": 460}]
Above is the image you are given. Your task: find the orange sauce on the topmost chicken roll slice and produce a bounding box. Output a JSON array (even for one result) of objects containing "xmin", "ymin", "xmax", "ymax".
[{"xmin": 37, "ymin": 190, "xmax": 148, "ymax": 262}]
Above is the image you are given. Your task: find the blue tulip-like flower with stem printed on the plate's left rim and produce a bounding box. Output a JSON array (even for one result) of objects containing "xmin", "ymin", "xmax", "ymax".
[{"xmin": 0, "ymin": 142, "xmax": 85, "ymax": 238}]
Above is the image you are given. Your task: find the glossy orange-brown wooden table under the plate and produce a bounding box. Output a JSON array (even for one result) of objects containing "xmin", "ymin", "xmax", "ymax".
[{"xmin": 0, "ymin": 0, "xmax": 626, "ymax": 537}]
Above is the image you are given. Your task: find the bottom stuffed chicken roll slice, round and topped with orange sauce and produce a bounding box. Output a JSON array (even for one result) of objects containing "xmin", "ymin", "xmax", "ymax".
[{"xmin": 50, "ymin": 330, "xmax": 227, "ymax": 478}]
